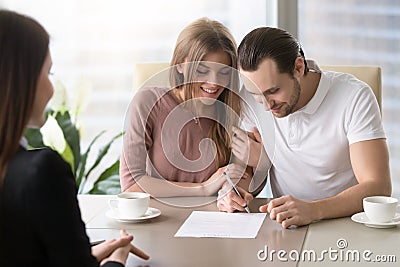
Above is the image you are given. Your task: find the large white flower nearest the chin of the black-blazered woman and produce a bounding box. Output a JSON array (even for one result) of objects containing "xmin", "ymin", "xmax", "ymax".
[{"xmin": 40, "ymin": 116, "xmax": 66, "ymax": 154}]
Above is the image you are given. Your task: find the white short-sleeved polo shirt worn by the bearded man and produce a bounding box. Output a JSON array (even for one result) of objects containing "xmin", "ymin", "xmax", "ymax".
[{"xmin": 241, "ymin": 71, "xmax": 385, "ymax": 201}]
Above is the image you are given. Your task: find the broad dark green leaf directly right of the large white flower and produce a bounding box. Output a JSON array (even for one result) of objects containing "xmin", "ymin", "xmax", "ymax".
[{"xmin": 55, "ymin": 110, "xmax": 81, "ymax": 175}]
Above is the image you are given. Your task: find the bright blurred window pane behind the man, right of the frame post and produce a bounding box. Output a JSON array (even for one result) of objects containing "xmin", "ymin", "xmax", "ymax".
[{"xmin": 298, "ymin": 0, "xmax": 400, "ymax": 196}]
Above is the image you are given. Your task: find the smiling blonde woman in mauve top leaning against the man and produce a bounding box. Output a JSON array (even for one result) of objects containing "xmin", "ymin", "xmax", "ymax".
[{"xmin": 120, "ymin": 18, "xmax": 252, "ymax": 209}]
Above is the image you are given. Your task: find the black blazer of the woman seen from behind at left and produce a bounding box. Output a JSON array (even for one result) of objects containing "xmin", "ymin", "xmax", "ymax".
[{"xmin": 0, "ymin": 147, "xmax": 123, "ymax": 267}]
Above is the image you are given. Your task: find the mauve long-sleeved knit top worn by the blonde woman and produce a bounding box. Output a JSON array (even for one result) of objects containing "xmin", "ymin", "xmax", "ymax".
[{"xmin": 120, "ymin": 87, "xmax": 217, "ymax": 190}]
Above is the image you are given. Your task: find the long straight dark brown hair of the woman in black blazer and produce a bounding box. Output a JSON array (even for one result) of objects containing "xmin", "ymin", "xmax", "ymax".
[{"xmin": 0, "ymin": 10, "xmax": 49, "ymax": 182}]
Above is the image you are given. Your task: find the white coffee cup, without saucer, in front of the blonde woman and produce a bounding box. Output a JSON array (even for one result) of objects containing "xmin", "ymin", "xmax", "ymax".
[{"xmin": 108, "ymin": 192, "xmax": 150, "ymax": 219}]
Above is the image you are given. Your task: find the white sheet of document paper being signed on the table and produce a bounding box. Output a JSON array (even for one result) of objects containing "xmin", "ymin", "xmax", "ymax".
[{"xmin": 175, "ymin": 211, "xmax": 267, "ymax": 238}]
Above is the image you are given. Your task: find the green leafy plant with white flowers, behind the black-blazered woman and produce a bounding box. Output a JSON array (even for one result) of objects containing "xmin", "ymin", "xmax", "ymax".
[{"xmin": 25, "ymin": 79, "xmax": 122, "ymax": 194}]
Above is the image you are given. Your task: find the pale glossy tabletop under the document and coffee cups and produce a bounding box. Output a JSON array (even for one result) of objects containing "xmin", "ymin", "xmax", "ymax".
[{"xmin": 78, "ymin": 195, "xmax": 400, "ymax": 267}]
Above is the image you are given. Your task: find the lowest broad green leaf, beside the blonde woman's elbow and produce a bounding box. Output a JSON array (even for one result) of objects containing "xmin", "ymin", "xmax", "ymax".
[{"xmin": 89, "ymin": 160, "xmax": 121, "ymax": 195}]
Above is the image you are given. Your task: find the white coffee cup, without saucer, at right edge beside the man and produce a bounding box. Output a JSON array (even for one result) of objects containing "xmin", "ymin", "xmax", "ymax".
[{"xmin": 363, "ymin": 196, "xmax": 399, "ymax": 223}]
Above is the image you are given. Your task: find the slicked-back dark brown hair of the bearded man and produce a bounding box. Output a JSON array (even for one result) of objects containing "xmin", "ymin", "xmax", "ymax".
[{"xmin": 238, "ymin": 27, "xmax": 308, "ymax": 76}]
